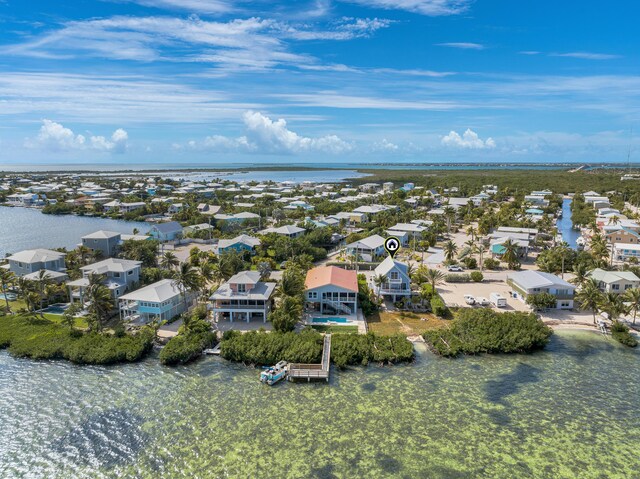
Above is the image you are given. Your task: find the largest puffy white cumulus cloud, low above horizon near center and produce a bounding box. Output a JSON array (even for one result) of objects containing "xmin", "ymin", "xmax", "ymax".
[{"xmin": 187, "ymin": 111, "xmax": 352, "ymax": 154}]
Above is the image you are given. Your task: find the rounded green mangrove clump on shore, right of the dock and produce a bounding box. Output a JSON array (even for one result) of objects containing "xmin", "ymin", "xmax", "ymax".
[{"xmin": 423, "ymin": 309, "xmax": 552, "ymax": 357}]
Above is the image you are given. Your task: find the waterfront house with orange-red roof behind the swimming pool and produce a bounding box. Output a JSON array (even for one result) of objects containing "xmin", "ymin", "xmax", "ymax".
[{"xmin": 304, "ymin": 266, "xmax": 358, "ymax": 314}]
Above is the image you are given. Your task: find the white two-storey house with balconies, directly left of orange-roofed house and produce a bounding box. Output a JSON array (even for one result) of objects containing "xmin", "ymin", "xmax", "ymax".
[{"xmin": 209, "ymin": 271, "xmax": 276, "ymax": 322}]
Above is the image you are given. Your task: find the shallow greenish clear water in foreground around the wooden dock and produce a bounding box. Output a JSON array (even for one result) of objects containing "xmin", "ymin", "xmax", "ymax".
[{"xmin": 0, "ymin": 332, "xmax": 640, "ymax": 479}]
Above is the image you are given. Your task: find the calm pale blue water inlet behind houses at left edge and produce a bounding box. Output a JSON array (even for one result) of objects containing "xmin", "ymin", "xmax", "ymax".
[{"xmin": 0, "ymin": 206, "xmax": 151, "ymax": 257}]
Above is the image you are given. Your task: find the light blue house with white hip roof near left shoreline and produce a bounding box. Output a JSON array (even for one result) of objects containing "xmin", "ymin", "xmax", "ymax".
[{"xmin": 119, "ymin": 279, "xmax": 195, "ymax": 324}]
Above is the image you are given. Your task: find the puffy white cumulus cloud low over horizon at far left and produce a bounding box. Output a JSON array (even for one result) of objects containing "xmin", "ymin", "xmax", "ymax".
[{"xmin": 25, "ymin": 119, "xmax": 129, "ymax": 153}]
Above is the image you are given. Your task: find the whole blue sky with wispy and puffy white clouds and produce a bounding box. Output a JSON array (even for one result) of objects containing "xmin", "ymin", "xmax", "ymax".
[{"xmin": 0, "ymin": 0, "xmax": 640, "ymax": 165}]
